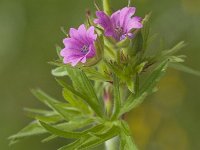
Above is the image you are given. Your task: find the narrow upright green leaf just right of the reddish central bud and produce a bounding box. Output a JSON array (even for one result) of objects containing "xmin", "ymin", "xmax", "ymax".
[{"xmin": 111, "ymin": 74, "xmax": 121, "ymax": 120}]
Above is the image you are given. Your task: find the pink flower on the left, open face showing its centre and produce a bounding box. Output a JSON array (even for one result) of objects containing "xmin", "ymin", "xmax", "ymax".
[{"xmin": 60, "ymin": 24, "xmax": 97, "ymax": 66}]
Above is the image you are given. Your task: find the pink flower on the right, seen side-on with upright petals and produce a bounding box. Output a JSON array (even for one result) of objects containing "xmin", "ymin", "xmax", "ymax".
[{"xmin": 94, "ymin": 7, "xmax": 143, "ymax": 41}]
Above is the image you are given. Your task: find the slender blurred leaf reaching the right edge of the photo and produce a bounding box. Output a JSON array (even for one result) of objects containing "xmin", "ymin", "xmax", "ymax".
[{"xmin": 169, "ymin": 63, "xmax": 200, "ymax": 76}]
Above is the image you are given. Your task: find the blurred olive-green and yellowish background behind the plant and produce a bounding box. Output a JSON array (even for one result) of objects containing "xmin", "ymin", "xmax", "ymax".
[{"xmin": 0, "ymin": 0, "xmax": 200, "ymax": 150}]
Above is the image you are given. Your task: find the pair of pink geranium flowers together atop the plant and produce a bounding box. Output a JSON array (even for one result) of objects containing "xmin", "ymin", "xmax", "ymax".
[{"xmin": 60, "ymin": 7, "xmax": 143, "ymax": 66}]
